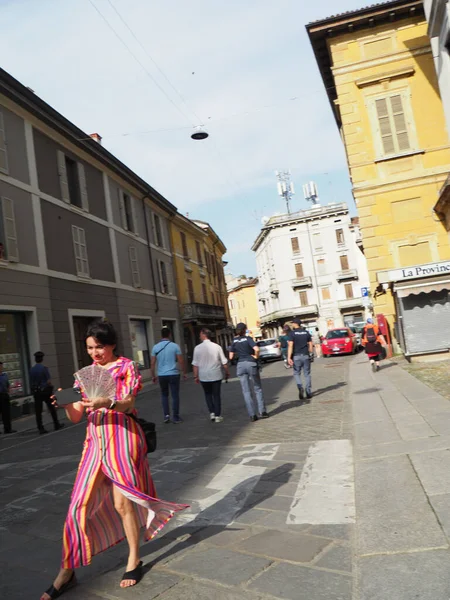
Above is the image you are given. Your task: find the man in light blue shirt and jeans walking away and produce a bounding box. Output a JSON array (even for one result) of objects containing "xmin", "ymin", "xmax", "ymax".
[{"xmin": 151, "ymin": 327, "xmax": 186, "ymax": 423}]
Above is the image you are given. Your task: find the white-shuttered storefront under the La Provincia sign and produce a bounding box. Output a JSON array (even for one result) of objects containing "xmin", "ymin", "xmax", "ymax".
[{"xmin": 378, "ymin": 261, "xmax": 450, "ymax": 357}]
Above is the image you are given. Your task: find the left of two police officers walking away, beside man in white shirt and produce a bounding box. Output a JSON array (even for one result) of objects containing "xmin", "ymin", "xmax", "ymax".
[{"xmin": 229, "ymin": 323, "xmax": 269, "ymax": 422}]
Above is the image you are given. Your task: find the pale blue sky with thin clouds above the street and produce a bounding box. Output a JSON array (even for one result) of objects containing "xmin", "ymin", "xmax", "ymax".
[{"xmin": 0, "ymin": 0, "xmax": 369, "ymax": 276}]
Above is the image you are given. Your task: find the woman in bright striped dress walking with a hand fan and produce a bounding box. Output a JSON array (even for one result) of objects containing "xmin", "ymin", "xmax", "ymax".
[{"xmin": 41, "ymin": 322, "xmax": 187, "ymax": 600}]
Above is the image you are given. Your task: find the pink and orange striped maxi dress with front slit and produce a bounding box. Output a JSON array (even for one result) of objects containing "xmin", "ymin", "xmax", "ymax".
[{"xmin": 62, "ymin": 357, "xmax": 188, "ymax": 569}]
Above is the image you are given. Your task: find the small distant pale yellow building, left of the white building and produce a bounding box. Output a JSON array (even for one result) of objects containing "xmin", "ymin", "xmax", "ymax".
[{"xmin": 227, "ymin": 276, "xmax": 261, "ymax": 339}]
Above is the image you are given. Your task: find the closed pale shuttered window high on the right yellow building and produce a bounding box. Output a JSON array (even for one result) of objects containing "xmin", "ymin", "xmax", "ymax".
[{"xmin": 373, "ymin": 90, "xmax": 412, "ymax": 156}]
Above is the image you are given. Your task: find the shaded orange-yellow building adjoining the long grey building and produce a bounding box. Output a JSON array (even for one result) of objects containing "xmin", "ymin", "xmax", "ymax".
[{"xmin": 171, "ymin": 213, "xmax": 232, "ymax": 365}]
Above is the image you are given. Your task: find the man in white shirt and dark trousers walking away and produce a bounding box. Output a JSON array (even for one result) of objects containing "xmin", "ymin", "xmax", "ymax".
[{"xmin": 192, "ymin": 329, "xmax": 230, "ymax": 423}]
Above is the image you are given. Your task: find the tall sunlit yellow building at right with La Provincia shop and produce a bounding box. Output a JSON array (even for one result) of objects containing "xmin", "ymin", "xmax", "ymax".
[{"xmin": 307, "ymin": 0, "xmax": 450, "ymax": 357}]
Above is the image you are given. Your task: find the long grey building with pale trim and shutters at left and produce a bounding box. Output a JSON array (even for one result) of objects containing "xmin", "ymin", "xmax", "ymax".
[{"xmin": 0, "ymin": 69, "xmax": 180, "ymax": 399}]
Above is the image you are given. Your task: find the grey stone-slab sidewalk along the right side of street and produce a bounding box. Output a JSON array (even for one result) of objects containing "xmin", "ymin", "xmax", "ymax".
[{"xmin": 350, "ymin": 355, "xmax": 450, "ymax": 600}]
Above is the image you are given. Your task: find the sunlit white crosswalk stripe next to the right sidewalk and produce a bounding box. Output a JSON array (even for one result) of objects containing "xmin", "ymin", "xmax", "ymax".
[{"xmin": 286, "ymin": 440, "xmax": 355, "ymax": 525}]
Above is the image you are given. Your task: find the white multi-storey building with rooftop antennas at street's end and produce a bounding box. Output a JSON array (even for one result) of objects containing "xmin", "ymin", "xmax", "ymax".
[{"xmin": 252, "ymin": 203, "xmax": 370, "ymax": 336}]
